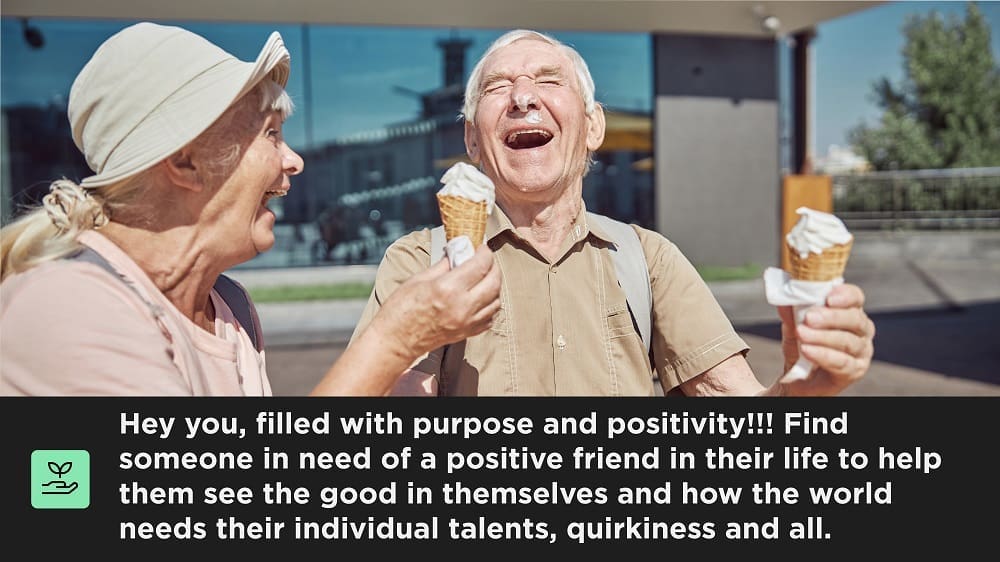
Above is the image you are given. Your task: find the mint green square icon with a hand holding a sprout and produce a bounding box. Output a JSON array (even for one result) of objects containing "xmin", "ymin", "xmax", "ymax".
[{"xmin": 31, "ymin": 449, "xmax": 90, "ymax": 509}]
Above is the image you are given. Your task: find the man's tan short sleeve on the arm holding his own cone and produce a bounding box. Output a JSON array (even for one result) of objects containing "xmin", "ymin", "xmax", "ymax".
[{"xmin": 639, "ymin": 229, "xmax": 750, "ymax": 392}]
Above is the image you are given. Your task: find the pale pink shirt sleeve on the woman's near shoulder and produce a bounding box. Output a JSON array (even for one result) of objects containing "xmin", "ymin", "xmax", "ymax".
[{"xmin": 0, "ymin": 262, "xmax": 191, "ymax": 396}]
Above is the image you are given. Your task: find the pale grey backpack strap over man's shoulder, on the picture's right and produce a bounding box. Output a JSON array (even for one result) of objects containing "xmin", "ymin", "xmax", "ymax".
[{"xmin": 587, "ymin": 212, "xmax": 653, "ymax": 352}]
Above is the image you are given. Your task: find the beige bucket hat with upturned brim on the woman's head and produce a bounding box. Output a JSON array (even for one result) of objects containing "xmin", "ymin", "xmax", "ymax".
[{"xmin": 68, "ymin": 22, "xmax": 290, "ymax": 188}]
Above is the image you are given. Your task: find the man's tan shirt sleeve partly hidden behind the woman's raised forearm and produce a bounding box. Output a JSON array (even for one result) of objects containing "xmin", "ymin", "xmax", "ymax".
[{"xmin": 348, "ymin": 229, "xmax": 444, "ymax": 375}]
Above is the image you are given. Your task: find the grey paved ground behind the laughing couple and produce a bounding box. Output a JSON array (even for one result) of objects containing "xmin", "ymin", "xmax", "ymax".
[{"xmin": 231, "ymin": 232, "xmax": 1000, "ymax": 396}]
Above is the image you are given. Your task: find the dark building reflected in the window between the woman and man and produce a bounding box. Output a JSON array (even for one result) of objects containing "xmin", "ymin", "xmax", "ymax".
[{"xmin": 284, "ymin": 37, "xmax": 470, "ymax": 259}]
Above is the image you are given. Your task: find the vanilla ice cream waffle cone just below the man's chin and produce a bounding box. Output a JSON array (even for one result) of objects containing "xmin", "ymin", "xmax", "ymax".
[{"xmin": 437, "ymin": 162, "xmax": 496, "ymax": 247}]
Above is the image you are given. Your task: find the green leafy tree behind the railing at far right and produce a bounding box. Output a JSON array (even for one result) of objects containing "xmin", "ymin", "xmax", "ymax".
[{"xmin": 848, "ymin": 2, "xmax": 1000, "ymax": 170}]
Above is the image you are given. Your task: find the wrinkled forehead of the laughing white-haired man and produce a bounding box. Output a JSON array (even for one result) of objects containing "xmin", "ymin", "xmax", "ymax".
[{"xmin": 479, "ymin": 37, "xmax": 578, "ymax": 87}]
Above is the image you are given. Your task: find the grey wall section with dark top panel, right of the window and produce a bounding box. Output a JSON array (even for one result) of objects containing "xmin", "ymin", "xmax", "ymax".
[{"xmin": 653, "ymin": 34, "xmax": 781, "ymax": 266}]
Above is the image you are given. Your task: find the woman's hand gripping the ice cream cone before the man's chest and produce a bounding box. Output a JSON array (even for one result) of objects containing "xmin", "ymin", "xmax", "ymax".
[{"xmin": 372, "ymin": 244, "xmax": 500, "ymax": 359}]
